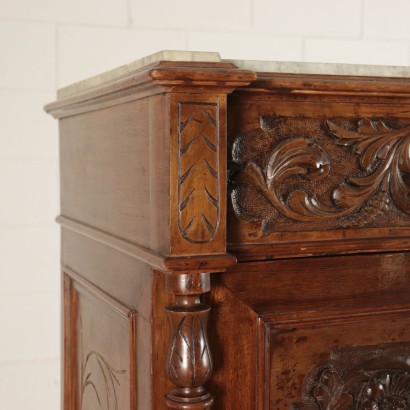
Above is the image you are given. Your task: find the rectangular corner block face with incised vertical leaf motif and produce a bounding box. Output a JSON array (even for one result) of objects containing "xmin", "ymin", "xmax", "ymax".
[{"xmin": 169, "ymin": 93, "xmax": 227, "ymax": 256}]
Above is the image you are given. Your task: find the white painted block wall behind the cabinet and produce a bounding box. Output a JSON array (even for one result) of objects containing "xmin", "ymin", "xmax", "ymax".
[{"xmin": 0, "ymin": 0, "xmax": 410, "ymax": 410}]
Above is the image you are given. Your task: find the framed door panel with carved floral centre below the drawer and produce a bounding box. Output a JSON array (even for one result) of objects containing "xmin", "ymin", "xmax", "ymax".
[{"xmin": 261, "ymin": 311, "xmax": 410, "ymax": 410}]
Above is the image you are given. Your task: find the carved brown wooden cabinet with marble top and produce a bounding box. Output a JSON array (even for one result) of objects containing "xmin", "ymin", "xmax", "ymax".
[{"xmin": 46, "ymin": 52, "xmax": 410, "ymax": 410}]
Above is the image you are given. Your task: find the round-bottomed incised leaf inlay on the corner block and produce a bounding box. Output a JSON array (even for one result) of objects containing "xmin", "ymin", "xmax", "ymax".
[{"xmin": 178, "ymin": 102, "xmax": 219, "ymax": 243}]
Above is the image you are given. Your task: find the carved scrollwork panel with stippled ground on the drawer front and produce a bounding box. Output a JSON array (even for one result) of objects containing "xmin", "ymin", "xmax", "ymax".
[{"xmin": 230, "ymin": 117, "xmax": 410, "ymax": 235}]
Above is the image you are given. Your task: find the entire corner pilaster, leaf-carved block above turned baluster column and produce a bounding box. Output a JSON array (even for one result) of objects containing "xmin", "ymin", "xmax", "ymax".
[{"xmin": 159, "ymin": 68, "xmax": 255, "ymax": 410}]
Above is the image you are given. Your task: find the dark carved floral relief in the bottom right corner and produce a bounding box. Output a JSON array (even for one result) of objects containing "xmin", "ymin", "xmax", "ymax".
[{"xmin": 298, "ymin": 343, "xmax": 410, "ymax": 410}]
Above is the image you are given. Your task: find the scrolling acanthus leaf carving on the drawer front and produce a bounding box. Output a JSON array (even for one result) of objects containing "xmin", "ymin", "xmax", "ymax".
[{"xmin": 230, "ymin": 119, "xmax": 410, "ymax": 234}]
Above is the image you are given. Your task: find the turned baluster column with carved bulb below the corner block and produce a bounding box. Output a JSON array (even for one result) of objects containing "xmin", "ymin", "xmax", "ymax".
[{"xmin": 166, "ymin": 273, "xmax": 213, "ymax": 410}]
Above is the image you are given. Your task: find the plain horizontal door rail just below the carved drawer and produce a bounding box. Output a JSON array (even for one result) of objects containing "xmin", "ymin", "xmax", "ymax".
[{"xmin": 221, "ymin": 252, "xmax": 410, "ymax": 314}]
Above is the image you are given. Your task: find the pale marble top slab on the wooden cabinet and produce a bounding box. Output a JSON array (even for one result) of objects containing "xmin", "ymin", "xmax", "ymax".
[{"xmin": 58, "ymin": 50, "xmax": 410, "ymax": 99}]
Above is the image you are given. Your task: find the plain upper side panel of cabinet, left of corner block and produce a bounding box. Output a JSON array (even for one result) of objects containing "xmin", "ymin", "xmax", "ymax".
[{"xmin": 60, "ymin": 96, "xmax": 169, "ymax": 250}]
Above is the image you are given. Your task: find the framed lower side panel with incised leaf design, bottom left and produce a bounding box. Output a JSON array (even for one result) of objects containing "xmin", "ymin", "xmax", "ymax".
[{"xmin": 65, "ymin": 276, "xmax": 136, "ymax": 410}]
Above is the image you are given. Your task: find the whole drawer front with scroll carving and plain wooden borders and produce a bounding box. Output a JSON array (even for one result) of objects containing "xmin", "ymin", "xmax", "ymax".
[{"xmin": 228, "ymin": 93, "xmax": 410, "ymax": 260}]
